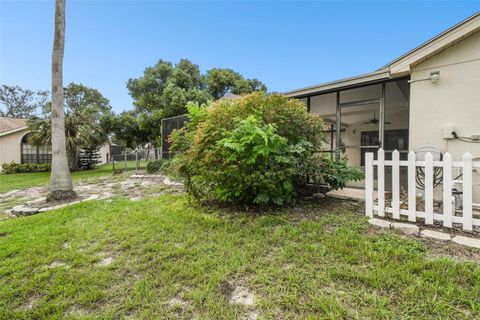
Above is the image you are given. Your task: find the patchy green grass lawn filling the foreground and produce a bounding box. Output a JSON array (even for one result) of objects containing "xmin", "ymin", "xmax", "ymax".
[{"xmin": 0, "ymin": 195, "xmax": 480, "ymax": 319}]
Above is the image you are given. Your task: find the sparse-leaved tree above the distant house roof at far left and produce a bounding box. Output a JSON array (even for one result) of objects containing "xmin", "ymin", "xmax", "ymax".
[{"xmin": 0, "ymin": 84, "xmax": 48, "ymax": 118}]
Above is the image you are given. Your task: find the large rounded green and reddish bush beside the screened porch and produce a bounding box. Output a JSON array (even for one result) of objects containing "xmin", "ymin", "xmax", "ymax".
[{"xmin": 170, "ymin": 93, "xmax": 362, "ymax": 205}]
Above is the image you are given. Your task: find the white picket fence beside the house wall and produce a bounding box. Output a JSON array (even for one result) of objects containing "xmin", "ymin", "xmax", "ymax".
[{"xmin": 365, "ymin": 149, "xmax": 480, "ymax": 231}]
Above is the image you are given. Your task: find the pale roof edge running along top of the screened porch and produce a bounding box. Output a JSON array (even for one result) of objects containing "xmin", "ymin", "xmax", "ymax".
[{"xmin": 284, "ymin": 68, "xmax": 391, "ymax": 98}]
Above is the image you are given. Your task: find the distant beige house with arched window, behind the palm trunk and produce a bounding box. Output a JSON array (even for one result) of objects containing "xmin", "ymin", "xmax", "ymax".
[{"xmin": 0, "ymin": 117, "xmax": 111, "ymax": 171}]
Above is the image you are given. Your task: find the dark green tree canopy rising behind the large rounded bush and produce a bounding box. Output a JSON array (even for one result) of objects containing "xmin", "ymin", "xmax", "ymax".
[{"xmin": 106, "ymin": 59, "xmax": 267, "ymax": 148}]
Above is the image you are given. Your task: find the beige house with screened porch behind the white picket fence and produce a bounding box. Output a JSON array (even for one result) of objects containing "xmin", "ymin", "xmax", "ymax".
[{"xmin": 285, "ymin": 13, "xmax": 480, "ymax": 199}]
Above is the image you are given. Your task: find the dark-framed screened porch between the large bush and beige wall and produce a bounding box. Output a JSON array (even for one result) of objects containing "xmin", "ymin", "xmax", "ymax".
[{"xmin": 290, "ymin": 78, "xmax": 410, "ymax": 188}]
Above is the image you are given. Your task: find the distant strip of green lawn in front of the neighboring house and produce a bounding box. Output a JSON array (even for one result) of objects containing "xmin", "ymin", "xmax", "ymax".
[{"xmin": 0, "ymin": 164, "xmax": 112, "ymax": 193}]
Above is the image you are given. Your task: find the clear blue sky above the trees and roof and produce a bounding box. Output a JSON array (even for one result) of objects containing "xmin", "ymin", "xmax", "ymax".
[{"xmin": 0, "ymin": 0, "xmax": 480, "ymax": 112}]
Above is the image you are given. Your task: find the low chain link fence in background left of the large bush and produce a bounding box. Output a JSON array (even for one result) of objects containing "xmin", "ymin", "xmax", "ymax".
[{"xmin": 112, "ymin": 148, "xmax": 158, "ymax": 172}]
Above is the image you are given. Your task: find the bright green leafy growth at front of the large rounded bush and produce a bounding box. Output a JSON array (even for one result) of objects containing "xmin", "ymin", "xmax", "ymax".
[{"xmin": 211, "ymin": 116, "xmax": 307, "ymax": 205}]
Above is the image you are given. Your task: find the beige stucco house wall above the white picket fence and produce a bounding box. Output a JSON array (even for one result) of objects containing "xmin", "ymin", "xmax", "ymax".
[{"xmin": 410, "ymin": 32, "xmax": 480, "ymax": 201}]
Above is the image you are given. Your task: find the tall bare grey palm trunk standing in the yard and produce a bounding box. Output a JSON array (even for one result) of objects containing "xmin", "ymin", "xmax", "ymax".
[{"xmin": 47, "ymin": 0, "xmax": 76, "ymax": 201}]
